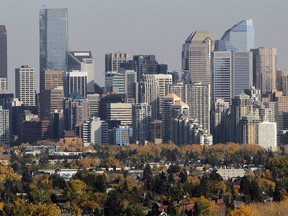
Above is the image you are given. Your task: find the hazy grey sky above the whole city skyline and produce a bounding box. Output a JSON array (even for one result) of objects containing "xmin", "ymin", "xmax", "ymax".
[{"xmin": 0, "ymin": 0, "xmax": 288, "ymax": 92}]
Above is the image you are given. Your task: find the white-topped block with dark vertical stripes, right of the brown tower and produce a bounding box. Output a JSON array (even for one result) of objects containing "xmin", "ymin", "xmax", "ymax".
[{"xmin": 64, "ymin": 71, "xmax": 87, "ymax": 98}]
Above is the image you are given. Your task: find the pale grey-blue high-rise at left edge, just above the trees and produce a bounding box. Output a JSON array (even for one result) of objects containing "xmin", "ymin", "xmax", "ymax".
[{"xmin": 0, "ymin": 106, "xmax": 11, "ymax": 146}]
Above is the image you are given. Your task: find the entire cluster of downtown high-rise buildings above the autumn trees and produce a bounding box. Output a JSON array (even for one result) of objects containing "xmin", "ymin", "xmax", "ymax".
[{"xmin": 0, "ymin": 9, "xmax": 288, "ymax": 149}]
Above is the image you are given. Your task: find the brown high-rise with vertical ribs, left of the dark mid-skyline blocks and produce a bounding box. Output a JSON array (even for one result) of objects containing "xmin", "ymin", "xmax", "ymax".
[{"xmin": 105, "ymin": 52, "xmax": 130, "ymax": 72}]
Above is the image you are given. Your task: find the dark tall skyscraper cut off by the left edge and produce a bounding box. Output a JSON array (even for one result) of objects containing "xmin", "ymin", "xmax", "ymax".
[{"xmin": 0, "ymin": 25, "xmax": 7, "ymax": 85}]
